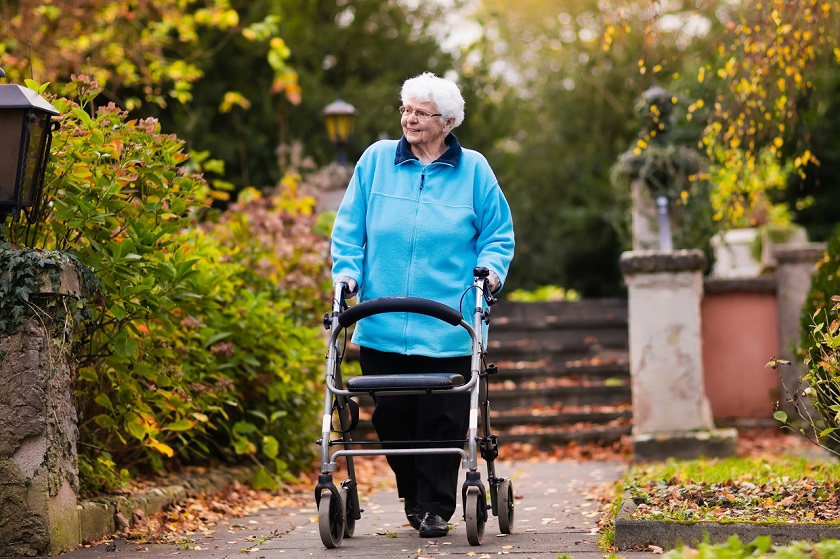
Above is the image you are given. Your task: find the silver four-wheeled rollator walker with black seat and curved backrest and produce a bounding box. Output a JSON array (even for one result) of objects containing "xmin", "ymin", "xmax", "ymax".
[{"xmin": 315, "ymin": 268, "xmax": 514, "ymax": 549}]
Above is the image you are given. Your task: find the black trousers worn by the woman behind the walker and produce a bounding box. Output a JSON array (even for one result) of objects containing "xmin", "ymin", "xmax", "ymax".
[{"xmin": 359, "ymin": 347, "xmax": 471, "ymax": 520}]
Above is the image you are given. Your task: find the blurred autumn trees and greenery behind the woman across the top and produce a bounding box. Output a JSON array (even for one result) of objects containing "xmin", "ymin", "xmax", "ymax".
[{"xmin": 0, "ymin": 0, "xmax": 840, "ymax": 297}]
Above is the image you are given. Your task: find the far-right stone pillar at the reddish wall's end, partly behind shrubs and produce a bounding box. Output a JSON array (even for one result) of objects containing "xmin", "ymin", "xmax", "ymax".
[{"xmin": 773, "ymin": 243, "xmax": 826, "ymax": 415}]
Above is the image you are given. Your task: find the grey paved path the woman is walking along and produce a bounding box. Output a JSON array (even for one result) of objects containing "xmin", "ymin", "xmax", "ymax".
[{"xmin": 61, "ymin": 461, "xmax": 652, "ymax": 559}]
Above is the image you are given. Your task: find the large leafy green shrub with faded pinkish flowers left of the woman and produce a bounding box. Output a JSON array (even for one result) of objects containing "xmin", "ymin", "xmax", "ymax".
[{"xmin": 12, "ymin": 79, "xmax": 329, "ymax": 490}]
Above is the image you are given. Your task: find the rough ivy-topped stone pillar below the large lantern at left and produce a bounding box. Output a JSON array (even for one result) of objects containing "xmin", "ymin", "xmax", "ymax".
[{"xmin": 0, "ymin": 262, "xmax": 81, "ymax": 557}]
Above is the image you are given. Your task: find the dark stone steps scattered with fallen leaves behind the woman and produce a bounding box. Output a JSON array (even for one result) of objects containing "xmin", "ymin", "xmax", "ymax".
[{"xmin": 346, "ymin": 298, "xmax": 632, "ymax": 446}]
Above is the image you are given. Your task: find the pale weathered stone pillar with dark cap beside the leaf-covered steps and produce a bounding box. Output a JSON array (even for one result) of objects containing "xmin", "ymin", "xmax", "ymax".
[{"xmin": 621, "ymin": 250, "xmax": 737, "ymax": 461}]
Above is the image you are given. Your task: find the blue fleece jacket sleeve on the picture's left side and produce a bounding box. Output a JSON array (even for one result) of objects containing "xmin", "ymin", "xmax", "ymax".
[{"xmin": 330, "ymin": 166, "xmax": 367, "ymax": 286}]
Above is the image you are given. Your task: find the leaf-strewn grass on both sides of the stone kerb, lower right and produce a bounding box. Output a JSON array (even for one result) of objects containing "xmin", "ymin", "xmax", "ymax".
[{"xmin": 599, "ymin": 455, "xmax": 840, "ymax": 559}]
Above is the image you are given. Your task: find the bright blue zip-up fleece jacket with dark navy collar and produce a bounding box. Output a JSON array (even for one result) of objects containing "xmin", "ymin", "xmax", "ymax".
[{"xmin": 332, "ymin": 134, "xmax": 514, "ymax": 357}]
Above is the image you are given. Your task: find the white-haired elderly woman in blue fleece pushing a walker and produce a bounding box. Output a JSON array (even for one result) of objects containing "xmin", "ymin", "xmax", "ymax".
[{"xmin": 332, "ymin": 72, "xmax": 514, "ymax": 537}]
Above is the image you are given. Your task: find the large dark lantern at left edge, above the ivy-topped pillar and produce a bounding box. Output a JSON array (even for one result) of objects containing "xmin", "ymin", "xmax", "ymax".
[{"xmin": 0, "ymin": 69, "xmax": 59, "ymax": 224}]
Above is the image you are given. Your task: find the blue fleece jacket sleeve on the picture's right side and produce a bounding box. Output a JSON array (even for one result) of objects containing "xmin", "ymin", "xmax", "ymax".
[{"xmin": 476, "ymin": 184, "xmax": 514, "ymax": 291}]
